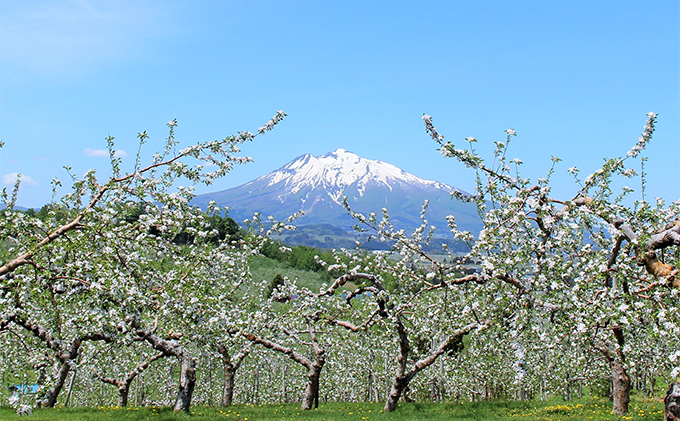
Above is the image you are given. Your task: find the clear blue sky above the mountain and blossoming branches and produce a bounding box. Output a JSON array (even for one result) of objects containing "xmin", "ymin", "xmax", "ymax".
[{"xmin": 0, "ymin": 0, "xmax": 680, "ymax": 207}]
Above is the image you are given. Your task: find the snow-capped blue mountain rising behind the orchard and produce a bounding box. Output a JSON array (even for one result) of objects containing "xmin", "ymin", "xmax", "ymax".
[{"xmin": 192, "ymin": 149, "xmax": 480, "ymax": 231}]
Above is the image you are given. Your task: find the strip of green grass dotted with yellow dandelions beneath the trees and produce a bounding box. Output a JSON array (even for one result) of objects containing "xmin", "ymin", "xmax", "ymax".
[{"xmin": 0, "ymin": 398, "xmax": 663, "ymax": 421}]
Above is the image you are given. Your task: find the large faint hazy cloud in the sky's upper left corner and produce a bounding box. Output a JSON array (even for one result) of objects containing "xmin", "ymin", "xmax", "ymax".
[{"xmin": 0, "ymin": 0, "xmax": 178, "ymax": 74}]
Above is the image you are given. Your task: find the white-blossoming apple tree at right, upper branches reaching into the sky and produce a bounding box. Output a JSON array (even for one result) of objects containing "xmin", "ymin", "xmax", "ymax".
[{"xmin": 414, "ymin": 113, "xmax": 680, "ymax": 414}]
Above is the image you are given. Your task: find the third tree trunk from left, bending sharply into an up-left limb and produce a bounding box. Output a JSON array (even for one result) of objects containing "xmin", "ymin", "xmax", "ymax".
[{"xmin": 136, "ymin": 329, "xmax": 196, "ymax": 412}]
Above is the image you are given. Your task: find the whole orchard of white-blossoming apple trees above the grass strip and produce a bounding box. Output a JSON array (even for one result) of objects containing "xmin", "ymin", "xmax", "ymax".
[{"xmin": 0, "ymin": 111, "xmax": 680, "ymax": 414}]
